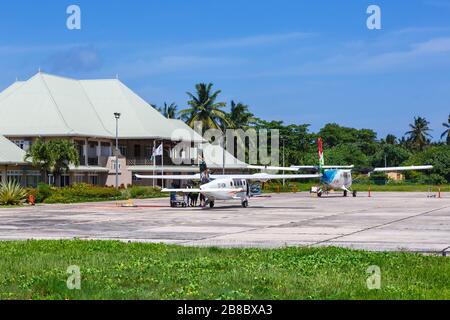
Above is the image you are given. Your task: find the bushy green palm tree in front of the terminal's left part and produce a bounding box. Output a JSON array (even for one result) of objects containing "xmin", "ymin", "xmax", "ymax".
[{"xmin": 25, "ymin": 139, "xmax": 80, "ymax": 186}]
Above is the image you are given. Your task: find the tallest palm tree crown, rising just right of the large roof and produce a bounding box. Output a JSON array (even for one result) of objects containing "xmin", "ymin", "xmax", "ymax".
[{"xmin": 180, "ymin": 83, "xmax": 229, "ymax": 129}]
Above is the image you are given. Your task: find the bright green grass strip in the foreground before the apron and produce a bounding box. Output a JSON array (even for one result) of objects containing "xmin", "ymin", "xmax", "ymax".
[{"xmin": 0, "ymin": 241, "xmax": 450, "ymax": 299}]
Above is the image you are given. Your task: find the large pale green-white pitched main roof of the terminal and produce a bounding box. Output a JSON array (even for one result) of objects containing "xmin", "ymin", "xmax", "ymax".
[{"xmin": 0, "ymin": 73, "xmax": 200, "ymax": 141}]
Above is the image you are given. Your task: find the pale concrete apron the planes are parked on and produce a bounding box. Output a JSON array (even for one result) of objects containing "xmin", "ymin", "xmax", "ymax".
[{"xmin": 0, "ymin": 193, "xmax": 450, "ymax": 255}]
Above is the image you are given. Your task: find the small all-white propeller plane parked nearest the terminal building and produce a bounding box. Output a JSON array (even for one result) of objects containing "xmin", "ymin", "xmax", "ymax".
[{"xmin": 136, "ymin": 167, "xmax": 321, "ymax": 208}]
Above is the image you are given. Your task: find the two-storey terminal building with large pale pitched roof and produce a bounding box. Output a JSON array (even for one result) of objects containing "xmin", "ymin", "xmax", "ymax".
[{"xmin": 0, "ymin": 72, "xmax": 247, "ymax": 186}]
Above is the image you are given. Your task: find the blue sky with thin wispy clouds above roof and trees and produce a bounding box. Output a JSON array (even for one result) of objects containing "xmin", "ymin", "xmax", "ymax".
[{"xmin": 0, "ymin": 0, "xmax": 450, "ymax": 139}]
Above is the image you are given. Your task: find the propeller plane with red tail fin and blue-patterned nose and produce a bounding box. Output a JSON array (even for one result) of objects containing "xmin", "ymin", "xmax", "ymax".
[{"xmin": 291, "ymin": 138, "xmax": 433, "ymax": 197}]
